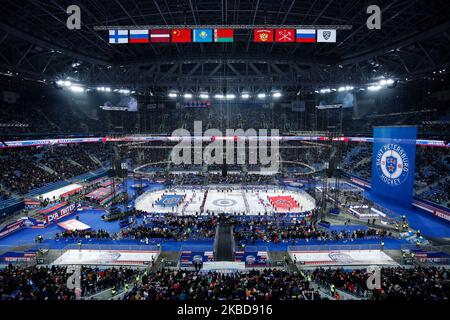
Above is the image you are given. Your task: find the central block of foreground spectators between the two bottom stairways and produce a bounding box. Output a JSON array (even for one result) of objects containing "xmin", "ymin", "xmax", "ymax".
[{"xmin": 124, "ymin": 269, "xmax": 320, "ymax": 301}]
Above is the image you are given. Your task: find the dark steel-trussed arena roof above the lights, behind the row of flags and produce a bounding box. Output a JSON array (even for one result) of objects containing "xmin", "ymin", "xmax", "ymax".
[{"xmin": 0, "ymin": 0, "xmax": 450, "ymax": 93}]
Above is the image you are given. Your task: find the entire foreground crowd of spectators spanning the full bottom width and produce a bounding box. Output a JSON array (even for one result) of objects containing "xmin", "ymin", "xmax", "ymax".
[{"xmin": 0, "ymin": 265, "xmax": 450, "ymax": 301}]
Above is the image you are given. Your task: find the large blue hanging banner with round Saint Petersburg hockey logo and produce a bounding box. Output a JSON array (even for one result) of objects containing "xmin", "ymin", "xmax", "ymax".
[{"xmin": 371, "ymin": 126, "xmax": 417, "ymax": 207}]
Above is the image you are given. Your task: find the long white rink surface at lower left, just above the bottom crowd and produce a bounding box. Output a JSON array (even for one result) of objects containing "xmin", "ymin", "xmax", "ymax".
[{"xmin": 53, "ymin": 249, "xmax": 159, "ymax": 266}]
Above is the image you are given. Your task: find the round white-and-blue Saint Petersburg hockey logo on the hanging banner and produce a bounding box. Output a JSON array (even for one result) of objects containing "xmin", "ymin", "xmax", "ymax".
[{"xmin": 376, "ymin": 144, "xmax": 409, "ymax": 186}]
